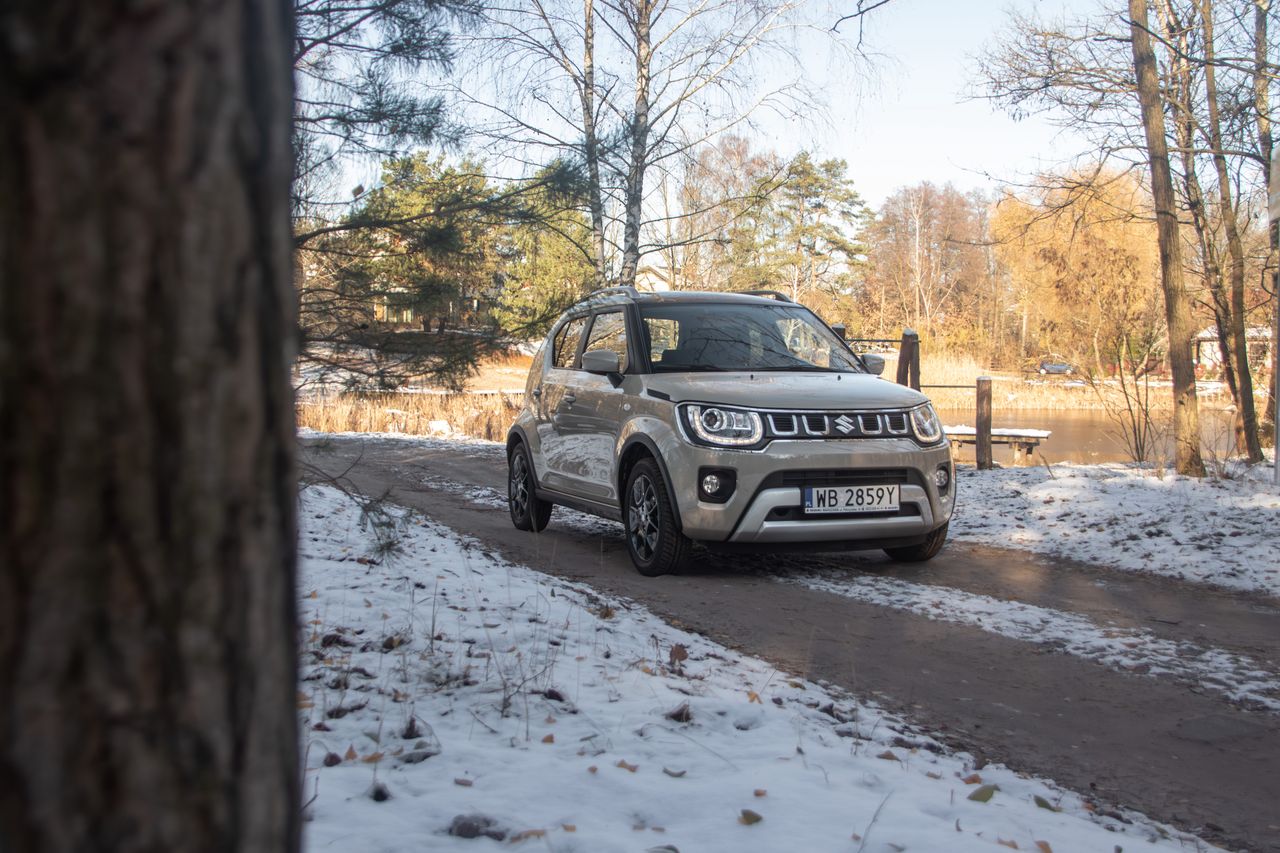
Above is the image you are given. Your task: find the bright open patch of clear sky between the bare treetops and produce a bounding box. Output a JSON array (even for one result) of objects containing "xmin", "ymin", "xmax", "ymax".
[{"xmin": 760, "ymin": 0, "xmax": 1097, "ymax": 207}]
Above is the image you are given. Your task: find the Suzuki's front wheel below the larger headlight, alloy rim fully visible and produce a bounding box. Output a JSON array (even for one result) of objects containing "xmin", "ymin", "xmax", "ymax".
[{"xmin": 622, "ymin": 459, "xmax": 692, "ymax": 578}]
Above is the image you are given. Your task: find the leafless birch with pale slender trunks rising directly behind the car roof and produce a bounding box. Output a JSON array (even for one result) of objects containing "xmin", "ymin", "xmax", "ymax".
[{"xmin": 463, "ymin": 0, "xmax": 870, "ymax": 284}]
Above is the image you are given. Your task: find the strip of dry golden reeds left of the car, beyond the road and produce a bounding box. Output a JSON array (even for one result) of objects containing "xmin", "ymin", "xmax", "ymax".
[{"xmin": 298, "ymin": 393, "xmax": 522, "ymax": 441}]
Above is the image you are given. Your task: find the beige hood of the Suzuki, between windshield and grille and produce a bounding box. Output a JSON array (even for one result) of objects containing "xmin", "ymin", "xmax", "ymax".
[{"xmin": 645, "ymin": 371, "xmax": 928, "ymax": 411}]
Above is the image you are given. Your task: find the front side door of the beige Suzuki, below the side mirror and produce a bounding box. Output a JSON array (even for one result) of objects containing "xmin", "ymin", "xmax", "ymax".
[{"xmin": 558, "ymin": 307, "xmax": 628, "ymax": 503}]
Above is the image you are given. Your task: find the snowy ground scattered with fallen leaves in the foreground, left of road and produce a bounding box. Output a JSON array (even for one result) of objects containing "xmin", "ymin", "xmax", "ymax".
[{"xmin": 298, "ymin": 487, "xmax": 1210, "ymax": 853}]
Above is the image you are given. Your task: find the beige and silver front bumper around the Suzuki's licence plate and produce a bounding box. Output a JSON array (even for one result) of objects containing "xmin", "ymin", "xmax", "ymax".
[{"xmin": 667, "ymin": 438, "xmax": 955, "ymax": 547}]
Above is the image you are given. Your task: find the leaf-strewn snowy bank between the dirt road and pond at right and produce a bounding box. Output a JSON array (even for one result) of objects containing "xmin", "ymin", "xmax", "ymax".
[{"xmin": 951, "ymin": 464, "xmax": 1280, "ymax": 596}]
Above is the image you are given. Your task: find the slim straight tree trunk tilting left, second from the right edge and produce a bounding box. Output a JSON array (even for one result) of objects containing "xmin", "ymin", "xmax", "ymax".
[{"xmin": 1201, "ymin": 0, "xmax": 1262, "ymax": 462}]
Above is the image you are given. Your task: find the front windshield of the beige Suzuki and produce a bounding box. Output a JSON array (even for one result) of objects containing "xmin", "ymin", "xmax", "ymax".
[{"xmin": 640, "ymin": 302, "xmax": 865, "ymax": 373}]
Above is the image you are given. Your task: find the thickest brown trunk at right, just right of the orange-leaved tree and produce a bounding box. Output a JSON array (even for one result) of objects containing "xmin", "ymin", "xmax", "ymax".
[{"xmin": 1129, "ymin": 0, "xmax": 1204, "ymax": 476}]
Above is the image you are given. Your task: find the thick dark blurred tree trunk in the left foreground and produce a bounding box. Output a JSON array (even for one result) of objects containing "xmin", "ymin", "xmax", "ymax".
[{"xmin": 0, "ymin": 0, "xmax": 300, "ymax": 853}]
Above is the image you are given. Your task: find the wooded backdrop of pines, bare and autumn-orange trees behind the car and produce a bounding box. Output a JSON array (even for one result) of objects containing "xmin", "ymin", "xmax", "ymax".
[{"xmin": 294, "ymin": 0, "xmax": 1280, "ymax": 459}]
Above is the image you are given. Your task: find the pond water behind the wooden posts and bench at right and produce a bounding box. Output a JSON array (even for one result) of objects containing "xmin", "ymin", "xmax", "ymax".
[{"xmin": 938, "ymin": 409, "xmax": 1234, "ymax": 465}]
